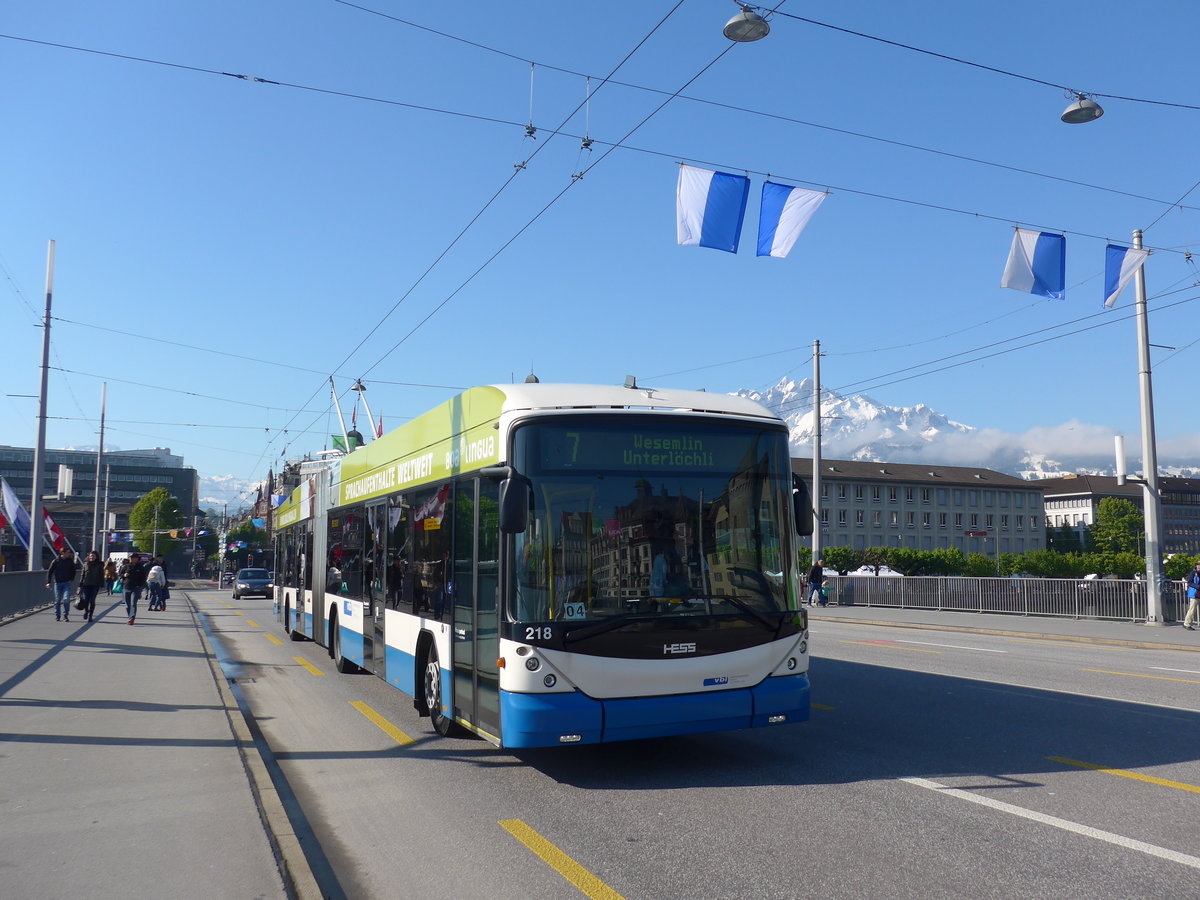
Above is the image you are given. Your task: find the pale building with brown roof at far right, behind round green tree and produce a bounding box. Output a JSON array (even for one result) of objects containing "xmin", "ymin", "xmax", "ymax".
[{"xmin": 1037, "ymin": 475, "xmax": 1200, "ymax": 553}]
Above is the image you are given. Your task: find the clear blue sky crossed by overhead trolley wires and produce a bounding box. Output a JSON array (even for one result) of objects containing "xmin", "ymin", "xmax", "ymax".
[{"xmin": 0, "ymin": 0, "xmax": 1200, "ymax": 504}]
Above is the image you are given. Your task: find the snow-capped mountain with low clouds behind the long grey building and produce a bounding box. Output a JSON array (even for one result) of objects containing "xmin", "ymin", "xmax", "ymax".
[{"xmin": 737, "ymin": 378, "xmax": 1200, "ymax": 479}]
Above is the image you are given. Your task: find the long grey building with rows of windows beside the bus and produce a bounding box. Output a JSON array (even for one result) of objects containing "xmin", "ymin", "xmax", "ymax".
[{"xmin": 792, "ymin": 457, "xmax": 1046, "ymax": 556}]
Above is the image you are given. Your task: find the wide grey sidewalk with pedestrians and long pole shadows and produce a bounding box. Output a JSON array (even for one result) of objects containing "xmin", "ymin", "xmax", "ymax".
[{"xmin": 0, "ymin": 584, "xmax": 317, "ymax": 900}]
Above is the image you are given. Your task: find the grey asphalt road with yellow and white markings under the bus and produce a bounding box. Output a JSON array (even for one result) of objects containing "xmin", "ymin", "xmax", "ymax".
[{"xmin": 190, "ymin": 590, "xmax": 1200, "ymax": 900}]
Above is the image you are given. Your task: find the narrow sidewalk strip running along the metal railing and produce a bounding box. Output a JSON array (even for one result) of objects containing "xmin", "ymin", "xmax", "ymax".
[{"xmin": 809, "ymin": 606, "xmax": 1200, "ymax": 652}]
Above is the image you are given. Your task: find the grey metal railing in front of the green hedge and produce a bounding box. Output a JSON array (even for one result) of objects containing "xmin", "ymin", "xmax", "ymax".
[{"xmin": 829, "ymin": 575, "xmax": 1187, "ymax": 622}]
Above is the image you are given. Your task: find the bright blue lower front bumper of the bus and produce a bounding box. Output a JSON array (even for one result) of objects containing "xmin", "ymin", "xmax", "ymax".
[{"xmin": 492, "ymin": 674, "xmax": 809, "ymax": 748}]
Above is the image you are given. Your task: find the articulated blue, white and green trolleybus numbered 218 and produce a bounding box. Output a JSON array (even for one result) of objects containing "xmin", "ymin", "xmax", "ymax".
[{"xmin": 275, "ymin": 383, "xmax": 812, "ymax": 748}]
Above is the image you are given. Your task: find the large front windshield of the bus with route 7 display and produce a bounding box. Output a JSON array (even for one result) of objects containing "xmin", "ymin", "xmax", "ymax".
[{"xmin": 509, "ymin": 416, "xmax": 792, "ymax": 622}]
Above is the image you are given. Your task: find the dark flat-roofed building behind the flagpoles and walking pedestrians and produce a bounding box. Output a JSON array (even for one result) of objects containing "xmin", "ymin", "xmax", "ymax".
[{"xmin": 0, "ymin": 445, "xmax": 200, "ymax": 569}]
